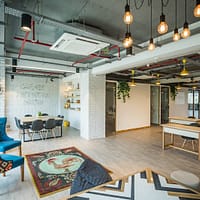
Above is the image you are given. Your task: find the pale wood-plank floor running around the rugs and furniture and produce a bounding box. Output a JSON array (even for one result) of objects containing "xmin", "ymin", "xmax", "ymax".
[{"xmin": 0, "ymin": 127, "xmax": 200, "ymax": 200}]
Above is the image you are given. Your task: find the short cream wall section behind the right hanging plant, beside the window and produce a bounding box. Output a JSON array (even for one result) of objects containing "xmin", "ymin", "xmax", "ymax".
[{"xmin": 169, "ymin": 88, "xmax": 188, "ymax": 117}]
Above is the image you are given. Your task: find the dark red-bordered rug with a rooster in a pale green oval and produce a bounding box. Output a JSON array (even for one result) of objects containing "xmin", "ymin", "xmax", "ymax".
[{"xmin": 26, "ymin": 147, "xmax": 92, "ymax": 197}]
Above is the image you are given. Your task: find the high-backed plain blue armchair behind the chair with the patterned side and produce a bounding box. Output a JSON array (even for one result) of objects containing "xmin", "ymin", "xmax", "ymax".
[{"xmin": 0, "ymin": 117, "xmax": 22, "ymax": 156}]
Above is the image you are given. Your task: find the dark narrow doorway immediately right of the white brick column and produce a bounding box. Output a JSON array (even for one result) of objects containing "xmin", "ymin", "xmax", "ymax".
[{"xmin": 105, "ymin": 82, "xmax": 116, "ymax": 137}]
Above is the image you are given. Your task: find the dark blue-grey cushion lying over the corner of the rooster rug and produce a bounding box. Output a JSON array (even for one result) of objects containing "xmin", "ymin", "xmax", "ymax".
[{"xmin": 70, "ymin": 159, "xmax": 112, "ymax": 194}]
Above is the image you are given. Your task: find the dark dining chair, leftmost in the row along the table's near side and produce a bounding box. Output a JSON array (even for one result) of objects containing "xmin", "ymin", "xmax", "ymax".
[{"xmin": 30, "ymin": 119, "xmax": 44, "ymax": 141}]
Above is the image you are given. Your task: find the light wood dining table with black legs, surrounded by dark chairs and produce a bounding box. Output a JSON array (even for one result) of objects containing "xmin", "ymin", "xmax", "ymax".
[{"xmin": 20, "ymin": 116, "xmax": 63, "ymax": 142}]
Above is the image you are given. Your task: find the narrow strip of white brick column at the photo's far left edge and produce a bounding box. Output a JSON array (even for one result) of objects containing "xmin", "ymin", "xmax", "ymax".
[{"xmin": 0, "ymin": 0, "xmax": 5, "ymax": 117}]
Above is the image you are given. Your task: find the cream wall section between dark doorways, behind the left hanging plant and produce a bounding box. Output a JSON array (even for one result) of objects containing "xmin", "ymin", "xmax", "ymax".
[{"xmin": 116, "ymin": 84, "xmax": 150, "ymax": 131}]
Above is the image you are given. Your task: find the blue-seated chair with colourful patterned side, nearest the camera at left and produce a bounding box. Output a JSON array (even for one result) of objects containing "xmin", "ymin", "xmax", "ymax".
[{"xmin": 0, "ymin": 154, "xmax": 24, "ymax": 181}]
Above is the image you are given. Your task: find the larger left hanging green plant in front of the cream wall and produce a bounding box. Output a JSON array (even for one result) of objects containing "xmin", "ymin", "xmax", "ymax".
[{"xmin": 117, "ymin": 81, "xmax": 130, "ymax": 103}]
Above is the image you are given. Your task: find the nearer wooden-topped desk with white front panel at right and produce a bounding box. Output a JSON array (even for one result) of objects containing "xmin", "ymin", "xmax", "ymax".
[{"xmin": 161, "ymin": 123, "xmax": 200, "ymax": 160}]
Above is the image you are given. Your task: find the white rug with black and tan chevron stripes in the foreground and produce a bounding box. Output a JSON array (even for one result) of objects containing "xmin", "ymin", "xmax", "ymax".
[{"xmin": 68, "ymin": 169, "xmax": 200, "ymax": 200}]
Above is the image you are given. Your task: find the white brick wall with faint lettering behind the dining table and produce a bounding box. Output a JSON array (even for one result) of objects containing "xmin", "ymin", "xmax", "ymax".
[{"xmin": 6, "ymin": 75, "xmax": 60, "ymax": 129}]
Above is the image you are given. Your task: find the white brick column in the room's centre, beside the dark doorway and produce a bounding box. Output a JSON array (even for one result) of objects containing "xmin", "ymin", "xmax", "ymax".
[{"xmin": 80, "ymin": 70, "xmax": 105, "ymax": 140}]
